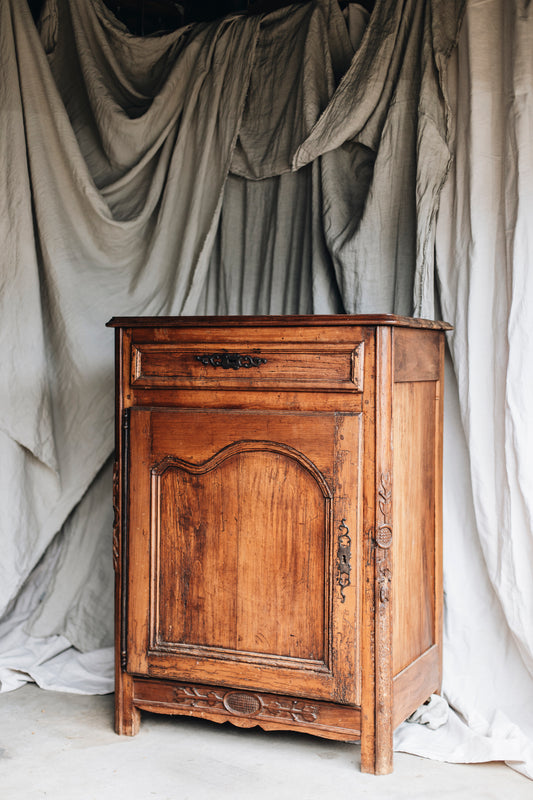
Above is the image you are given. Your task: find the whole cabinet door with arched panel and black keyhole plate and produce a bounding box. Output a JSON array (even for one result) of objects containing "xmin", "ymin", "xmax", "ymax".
[{"xmin": 126, "ymin": 408, "xmax": 361, "ymax": 705}]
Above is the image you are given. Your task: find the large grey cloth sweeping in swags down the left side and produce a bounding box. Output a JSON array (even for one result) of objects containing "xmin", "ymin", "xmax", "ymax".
[{"xmin": 0, "ymin": 0, "xmax": 259, "ymax": 610}]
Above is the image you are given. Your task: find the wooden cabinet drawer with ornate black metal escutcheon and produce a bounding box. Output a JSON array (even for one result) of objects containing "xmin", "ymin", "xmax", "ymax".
[{"xmin": 131, "ymin": 342, "xmax": 364, "ymax": 392}]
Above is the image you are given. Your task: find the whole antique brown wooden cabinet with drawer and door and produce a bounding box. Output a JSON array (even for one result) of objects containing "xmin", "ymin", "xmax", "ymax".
[{"xmin": 108, "ymin": 315, "xmax": 449, "ymax": 774}]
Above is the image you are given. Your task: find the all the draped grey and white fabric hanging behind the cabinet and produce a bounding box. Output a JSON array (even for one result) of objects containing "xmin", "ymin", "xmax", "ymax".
[{"xmin": 0, "ymin": 0, "xmax": 533, "ymax": 777}]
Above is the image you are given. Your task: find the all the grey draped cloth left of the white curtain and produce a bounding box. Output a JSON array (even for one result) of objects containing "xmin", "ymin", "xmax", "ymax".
[{"xmin": 0, "ymin": 0, "xmax": 459, "ymax": 664}]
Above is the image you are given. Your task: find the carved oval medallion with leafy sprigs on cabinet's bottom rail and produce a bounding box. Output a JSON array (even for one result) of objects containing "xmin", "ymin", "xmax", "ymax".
[{"xmin": 173, "ymin": 686, "xmax": 318, "ymax": 723}]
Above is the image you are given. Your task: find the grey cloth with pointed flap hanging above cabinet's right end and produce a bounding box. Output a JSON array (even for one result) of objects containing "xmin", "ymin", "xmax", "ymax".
[{"xmin": 293, "ymin": 0, "xmax": 465, "ymax": 318}]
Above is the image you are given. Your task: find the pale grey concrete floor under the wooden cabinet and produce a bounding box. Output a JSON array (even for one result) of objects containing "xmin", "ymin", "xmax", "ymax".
[{"xmin": 0, "ymin": 684, "xmax": 533, "ymax": 800}]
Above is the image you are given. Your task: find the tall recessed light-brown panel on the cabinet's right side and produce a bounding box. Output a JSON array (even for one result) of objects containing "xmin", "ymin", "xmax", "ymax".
[{"xmin": 392, "ymin": 381, "xmax": 438, "ymax": 675}]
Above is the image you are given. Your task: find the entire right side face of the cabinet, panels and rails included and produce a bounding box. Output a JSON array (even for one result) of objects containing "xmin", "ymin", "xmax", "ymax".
[{"xmin": 392, "ymin": 329, "xmax": 445, "ymax": 725}]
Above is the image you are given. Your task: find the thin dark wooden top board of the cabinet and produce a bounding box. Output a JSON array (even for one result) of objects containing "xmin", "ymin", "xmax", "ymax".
[{"xmin": 107, "ymin": 314, "xmax": 452, "ymax": 331}]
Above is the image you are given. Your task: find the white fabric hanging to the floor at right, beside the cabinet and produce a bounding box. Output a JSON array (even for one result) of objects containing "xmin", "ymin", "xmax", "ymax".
[{"xmin": 400, "ymin": 0, "xmax": 533, "ymax": 778}]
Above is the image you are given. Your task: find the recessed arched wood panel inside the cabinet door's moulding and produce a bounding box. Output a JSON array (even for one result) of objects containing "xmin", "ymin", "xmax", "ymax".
[{"xmin": 155, "ymin": 444, "xmax": 331, "ymax": 662}]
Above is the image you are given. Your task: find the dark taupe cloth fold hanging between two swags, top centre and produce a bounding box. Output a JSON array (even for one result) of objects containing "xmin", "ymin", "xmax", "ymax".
[{"xmin": 231, "ymin": 0, "xmax": 353, "ymax": 180}]
